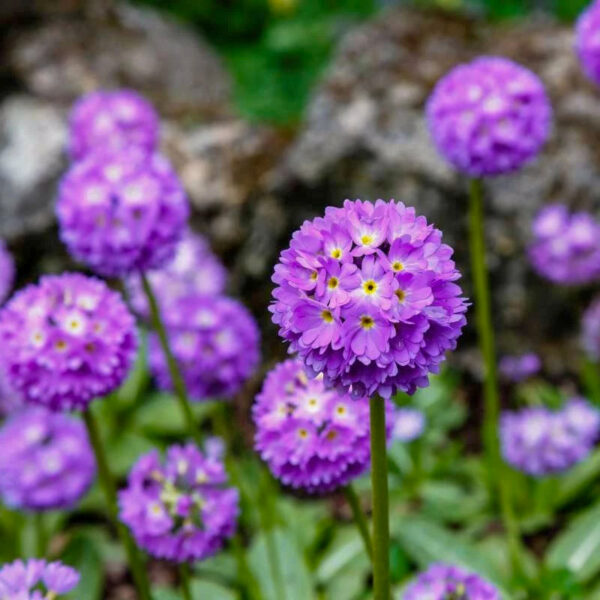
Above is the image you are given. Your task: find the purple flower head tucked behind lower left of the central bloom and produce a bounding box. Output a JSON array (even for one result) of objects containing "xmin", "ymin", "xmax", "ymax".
[{"xmin": 252, "ymin": 359, "xmax": 392, "ymax": 494}]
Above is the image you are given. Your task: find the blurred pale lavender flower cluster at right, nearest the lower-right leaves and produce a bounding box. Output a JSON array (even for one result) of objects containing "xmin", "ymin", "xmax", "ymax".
[{"xmin": 500, "ymin": 398, "xmax": 600, "ymax": 476}]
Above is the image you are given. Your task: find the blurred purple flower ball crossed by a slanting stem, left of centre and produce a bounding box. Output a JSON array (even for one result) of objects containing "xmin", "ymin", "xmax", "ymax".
[{"xmin": 149, "ymin": 296, "xmax": 259, "ymax": 401}]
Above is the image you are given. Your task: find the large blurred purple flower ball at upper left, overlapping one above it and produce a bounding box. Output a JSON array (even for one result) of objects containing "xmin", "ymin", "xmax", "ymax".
[{"xmin": 56, "ymin": 148, "xmax": 189, "ymax": 276}]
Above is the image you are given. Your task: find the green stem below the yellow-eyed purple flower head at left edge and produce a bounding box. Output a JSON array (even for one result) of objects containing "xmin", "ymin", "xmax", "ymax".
[{"xmin": 83, "ymin": 407, "xmax": 152, "ymax": 600}]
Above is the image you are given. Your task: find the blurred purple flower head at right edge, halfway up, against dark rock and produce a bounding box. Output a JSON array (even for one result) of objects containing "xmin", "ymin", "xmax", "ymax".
[{"xmin": 529, "ymin": 204, "xmax": 600, "ymax": 285}]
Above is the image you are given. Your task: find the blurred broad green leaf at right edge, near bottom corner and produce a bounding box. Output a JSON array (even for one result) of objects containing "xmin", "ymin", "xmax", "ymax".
[{"xmin": 546, "ymin": 503, "xmax": 600, "ymax": 582}]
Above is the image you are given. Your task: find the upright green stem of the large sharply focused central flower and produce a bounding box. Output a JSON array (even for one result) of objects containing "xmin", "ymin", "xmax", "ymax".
[{"xmin": 369, "ymin": 394, "xmax": 390, "ymax": 600}]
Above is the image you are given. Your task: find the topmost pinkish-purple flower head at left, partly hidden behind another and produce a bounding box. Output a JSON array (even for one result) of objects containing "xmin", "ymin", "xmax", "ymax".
[{"xmin": 69, "ymin": 90, "xmax": 159, "ymax": 160}]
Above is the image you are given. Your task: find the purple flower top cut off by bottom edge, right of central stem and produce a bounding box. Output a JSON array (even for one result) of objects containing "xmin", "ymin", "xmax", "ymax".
[{"xmin": 402, "ymin": 564, "xmax": 500, "ymax": 600}]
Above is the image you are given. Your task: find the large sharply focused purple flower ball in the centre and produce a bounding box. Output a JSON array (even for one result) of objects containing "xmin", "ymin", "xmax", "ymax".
[{"xmin": 270, "ymin": 200, "xmax": 467, "ymax": 398}]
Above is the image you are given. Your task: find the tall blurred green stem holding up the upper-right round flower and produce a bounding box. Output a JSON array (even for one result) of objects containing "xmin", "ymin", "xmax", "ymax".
[{"xmin": 469, "ymin": 179, "xmax": 522, "ymax": 572}]
